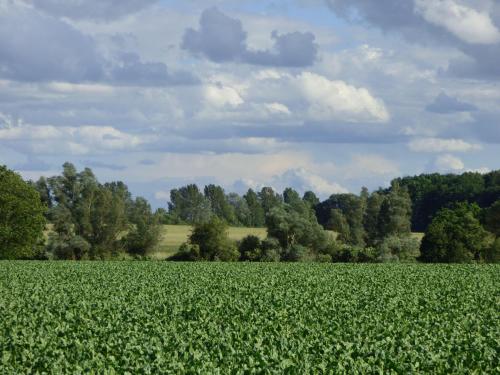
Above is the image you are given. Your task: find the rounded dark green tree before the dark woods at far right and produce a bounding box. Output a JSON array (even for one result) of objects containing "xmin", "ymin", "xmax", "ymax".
[{"xmin": 420, "ymin": 203, "xmax": 491, "ymax": 263}]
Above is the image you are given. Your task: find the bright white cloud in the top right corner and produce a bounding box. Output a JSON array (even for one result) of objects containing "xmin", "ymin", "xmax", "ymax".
[{"xmin": 415, "ymin": 0, "xmax": 500, "ymax": 44}]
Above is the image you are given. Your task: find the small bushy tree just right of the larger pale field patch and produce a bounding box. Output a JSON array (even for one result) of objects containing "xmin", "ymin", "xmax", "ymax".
[{"xmin": 189, "ymin": 216, "xmax": 239, "ymax": 261}]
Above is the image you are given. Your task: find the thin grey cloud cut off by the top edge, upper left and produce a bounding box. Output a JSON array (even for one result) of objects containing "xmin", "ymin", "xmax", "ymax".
[{"xmin": 24, "ymin": 0, "xmax": 158, "ymax": 20}]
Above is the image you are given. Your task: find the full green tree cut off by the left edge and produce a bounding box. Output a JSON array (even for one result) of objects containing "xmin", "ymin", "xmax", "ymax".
[{"xmin": 0, "ymin": 166, "xmax": 46, "ymax": 259}]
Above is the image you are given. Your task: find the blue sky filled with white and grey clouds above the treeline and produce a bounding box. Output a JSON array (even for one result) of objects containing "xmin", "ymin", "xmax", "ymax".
[{"xmin": 0, "ymin": 0, "xmax": 500, "ymax": 207}]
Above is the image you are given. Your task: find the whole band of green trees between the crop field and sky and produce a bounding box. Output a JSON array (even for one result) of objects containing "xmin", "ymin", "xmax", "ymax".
[{"xmin": 0, "ymin": 163, "xmax": 500, "ymax": 262}]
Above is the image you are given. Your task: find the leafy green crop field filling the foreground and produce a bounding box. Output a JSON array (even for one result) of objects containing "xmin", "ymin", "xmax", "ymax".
[{"xmin": 0, "ymin": 262, "xmax": 500, "ymax": 374}]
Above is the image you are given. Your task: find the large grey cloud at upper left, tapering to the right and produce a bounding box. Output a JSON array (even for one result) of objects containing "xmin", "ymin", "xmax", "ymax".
[{"xmin": 0, "ymin": 6, "xmax": 198, "ymax": 86}]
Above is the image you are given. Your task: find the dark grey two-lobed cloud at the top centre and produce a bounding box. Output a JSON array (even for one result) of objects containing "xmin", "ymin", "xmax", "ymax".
[{"xmin": 182, "ymin": 8, "xmax": 317, "ymax": 67}]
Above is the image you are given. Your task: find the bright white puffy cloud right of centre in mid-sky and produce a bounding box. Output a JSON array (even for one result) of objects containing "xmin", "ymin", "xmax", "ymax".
[{"xmin": 296, "ymin": 72, "xmax": 390, "ymax": 122}]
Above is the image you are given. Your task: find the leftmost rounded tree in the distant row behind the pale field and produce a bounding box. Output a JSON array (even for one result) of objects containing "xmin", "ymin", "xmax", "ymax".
[{"xmin": 168, "ymin": 184, "xmax": 212, "ymax": 224}]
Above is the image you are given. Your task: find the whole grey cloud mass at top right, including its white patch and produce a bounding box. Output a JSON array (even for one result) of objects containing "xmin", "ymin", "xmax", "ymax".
[{"xmin": 326, "ymin": 0, "xmax": 500, "ymax": 80}]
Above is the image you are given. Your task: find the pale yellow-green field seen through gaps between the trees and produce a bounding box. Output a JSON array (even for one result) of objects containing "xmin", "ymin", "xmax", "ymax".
[{"xmin": 152, "ymin": 225, "xmax": 267, "ymax": 259}]
